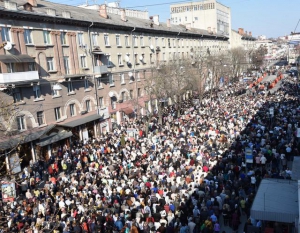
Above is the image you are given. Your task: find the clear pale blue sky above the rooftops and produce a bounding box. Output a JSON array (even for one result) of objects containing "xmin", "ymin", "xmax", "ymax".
[{"xmin": 48, "ymin": 0, "xmax": 300, "ymax": 38}]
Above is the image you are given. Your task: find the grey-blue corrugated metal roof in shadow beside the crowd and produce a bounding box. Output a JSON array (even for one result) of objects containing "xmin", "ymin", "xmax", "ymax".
[{"xmin": 251, "ymin": 179, "xmax": 299, "ymax": 223}]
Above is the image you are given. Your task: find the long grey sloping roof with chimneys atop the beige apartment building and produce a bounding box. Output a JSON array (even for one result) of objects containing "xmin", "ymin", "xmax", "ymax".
[{"xmin": 0, "ymin": 0, "xmax": 228, "ymax": 39}]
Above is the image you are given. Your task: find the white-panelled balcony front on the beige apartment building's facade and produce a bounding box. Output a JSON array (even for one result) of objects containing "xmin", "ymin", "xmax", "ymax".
[{"xmin": 0, "ymin": 71, "xmax": 39, "ymax": 84}]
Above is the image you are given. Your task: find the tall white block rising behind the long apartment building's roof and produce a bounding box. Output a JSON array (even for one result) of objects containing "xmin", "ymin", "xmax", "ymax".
[{"xmin": 170, "ymin": 0, "xmax": 231, "ymax": 36}]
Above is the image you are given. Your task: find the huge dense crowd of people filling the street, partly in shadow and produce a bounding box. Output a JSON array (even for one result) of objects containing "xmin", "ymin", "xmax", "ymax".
[{"xmin": 0, "ymin": 73, "xmax": 300, "ymax": 233}]
